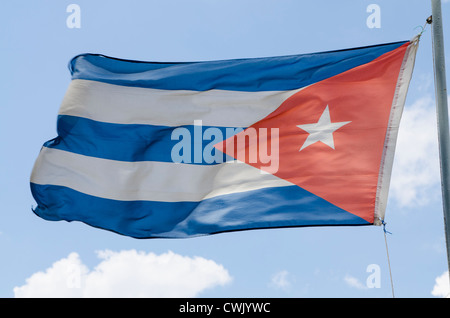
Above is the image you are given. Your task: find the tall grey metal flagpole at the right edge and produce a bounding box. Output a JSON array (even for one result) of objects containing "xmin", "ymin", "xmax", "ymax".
[{"xmin": 431, "ymin": 0, "xmax": 450, "ymax": 284}]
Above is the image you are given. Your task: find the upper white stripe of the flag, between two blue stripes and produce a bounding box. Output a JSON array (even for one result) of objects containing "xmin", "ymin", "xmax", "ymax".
[{"xmin": 59, "ymin": 79, "xmax": 300, "ymax": 127}]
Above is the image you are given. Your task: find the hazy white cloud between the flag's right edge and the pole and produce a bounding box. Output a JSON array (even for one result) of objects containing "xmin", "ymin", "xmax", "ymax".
[{"xmin": 390, "ymin": 97, "xmax": 440, "ymax": 206}]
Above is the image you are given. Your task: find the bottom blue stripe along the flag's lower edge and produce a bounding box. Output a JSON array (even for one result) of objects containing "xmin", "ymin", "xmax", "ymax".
[{"xmin": 31, "ymin": 183, "xmax": 370, "ymax": 238}]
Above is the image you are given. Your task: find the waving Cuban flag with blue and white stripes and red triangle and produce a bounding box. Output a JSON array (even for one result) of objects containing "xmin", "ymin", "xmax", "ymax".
[{"xmin": 30, "ymin": 38, "xmax": 418, "ymax": 238}]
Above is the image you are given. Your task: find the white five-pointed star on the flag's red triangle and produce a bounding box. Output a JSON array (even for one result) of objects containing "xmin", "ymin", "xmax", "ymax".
[{"xmin": 297, "ymin": 105, "xmax": 351, "ymax": 151}]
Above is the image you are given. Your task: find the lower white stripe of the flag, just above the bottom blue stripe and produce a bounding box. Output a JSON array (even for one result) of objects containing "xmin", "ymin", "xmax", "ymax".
[{"xmin": 31, "ymin": 147, "xmax": 292, "ymax": 202}]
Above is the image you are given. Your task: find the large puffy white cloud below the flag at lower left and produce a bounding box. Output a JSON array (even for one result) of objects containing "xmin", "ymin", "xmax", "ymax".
[{"xmin": 14, "ymin": 250, "xmax": 231, "ymax": 298}]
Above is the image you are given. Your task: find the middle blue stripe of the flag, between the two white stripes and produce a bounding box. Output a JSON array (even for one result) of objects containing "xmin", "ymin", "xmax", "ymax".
[{"xmin": 44, "ymin": 115, "xmax": 240, "ymax": 165}]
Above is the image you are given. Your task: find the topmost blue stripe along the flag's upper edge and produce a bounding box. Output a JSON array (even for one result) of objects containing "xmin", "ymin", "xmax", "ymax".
[{"xmin": 69, "ymin": 41, "xmax": 409, "ymax": 92}]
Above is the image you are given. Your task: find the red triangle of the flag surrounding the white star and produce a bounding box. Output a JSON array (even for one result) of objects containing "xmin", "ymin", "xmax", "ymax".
[{"xmin": 216, "ymin": 44, "xmax": 408, "ymax": 223}]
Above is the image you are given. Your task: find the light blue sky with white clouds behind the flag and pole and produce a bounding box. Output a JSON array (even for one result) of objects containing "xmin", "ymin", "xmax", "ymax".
[{"xmin": 0, "ymin": 0, "xmax": 450, "ymax": 298}]
